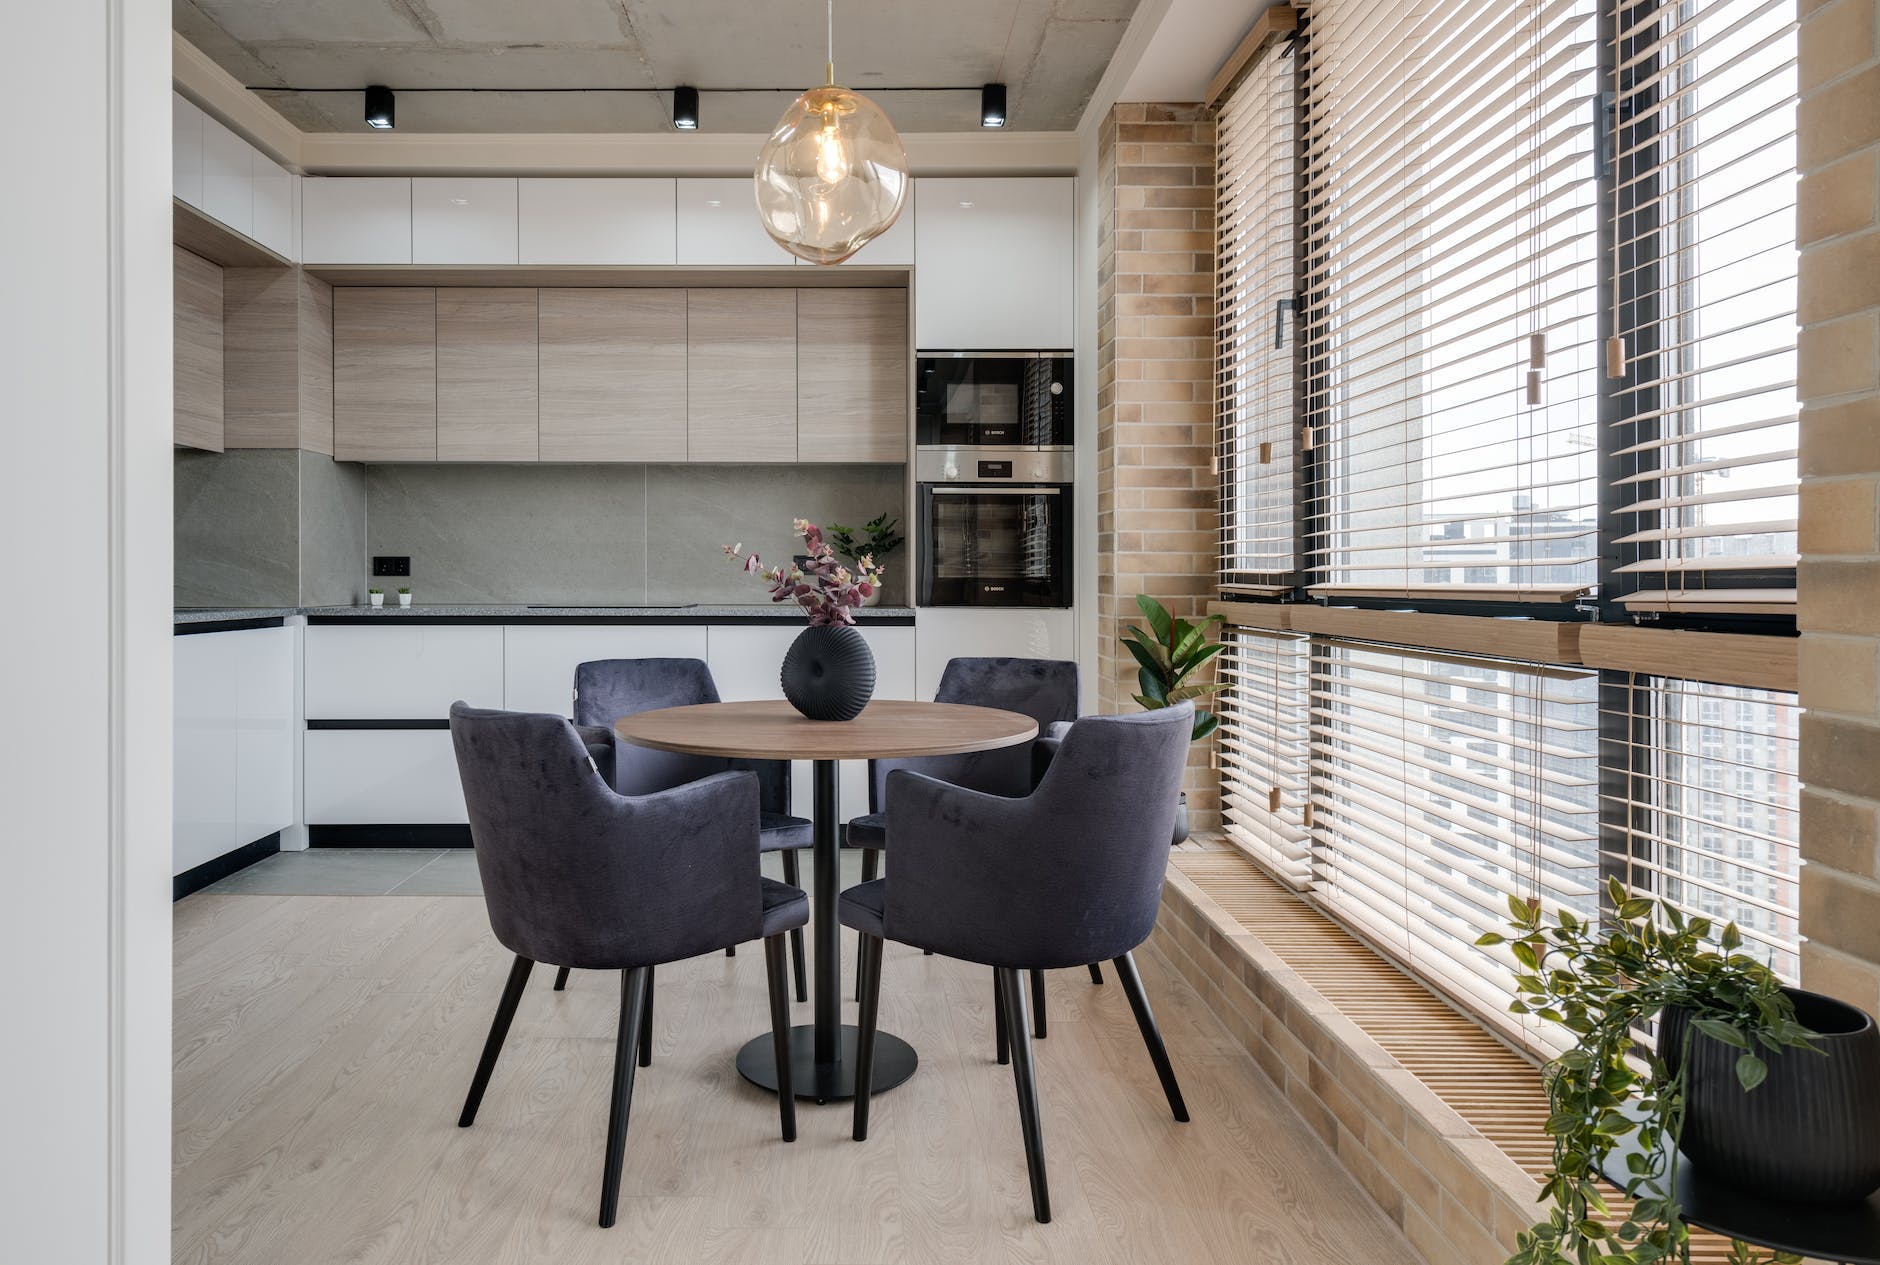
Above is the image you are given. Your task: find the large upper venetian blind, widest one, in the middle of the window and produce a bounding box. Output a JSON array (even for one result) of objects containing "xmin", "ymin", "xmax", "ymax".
[{"xmin": 1303, "ymin": 0, "xmax": 1600, "ymax": 600}]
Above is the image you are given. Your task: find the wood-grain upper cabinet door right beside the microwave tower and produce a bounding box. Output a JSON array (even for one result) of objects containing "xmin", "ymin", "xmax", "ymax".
[{"xmin": 797, "ymin": 289, "xmax": 908, "ymax": 461}]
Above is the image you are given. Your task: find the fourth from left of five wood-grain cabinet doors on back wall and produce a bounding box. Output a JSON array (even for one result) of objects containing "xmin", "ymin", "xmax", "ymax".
[{"xmin": 686, "ymin": 289, "xmax": 797, "ymax": 462}]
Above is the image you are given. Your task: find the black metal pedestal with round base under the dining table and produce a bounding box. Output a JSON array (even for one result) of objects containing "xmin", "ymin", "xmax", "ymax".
[{"xmin": 737, "ymin": 759, "xmax": 919, "ymax": 1103}]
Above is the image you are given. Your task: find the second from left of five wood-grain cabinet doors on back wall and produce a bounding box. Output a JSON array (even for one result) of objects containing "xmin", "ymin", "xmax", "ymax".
[{"xmin": 436, "ymin": 289, "xmax": 536, "ymax": 461}]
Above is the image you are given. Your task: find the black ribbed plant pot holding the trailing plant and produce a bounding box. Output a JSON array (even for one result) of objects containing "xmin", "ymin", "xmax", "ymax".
[{"xmin": 1658, "ymin": 989, "xmax": 1880, "ymax": 1203}]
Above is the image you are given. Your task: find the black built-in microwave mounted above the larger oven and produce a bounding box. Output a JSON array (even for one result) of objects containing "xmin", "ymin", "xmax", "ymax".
[{"xmin": 914, "ymin": 351, "xmax": 1072, "ymax": 447}]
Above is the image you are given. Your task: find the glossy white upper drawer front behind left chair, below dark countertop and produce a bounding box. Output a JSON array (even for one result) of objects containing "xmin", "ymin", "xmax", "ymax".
[{"xmin": 306, "ymin": 624, "xmax": 502, "ymax": 720}]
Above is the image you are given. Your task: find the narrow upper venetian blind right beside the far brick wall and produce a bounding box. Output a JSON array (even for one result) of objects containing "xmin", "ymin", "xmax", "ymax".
[{"xmin": 1214, "ymin": 37, "xmax": 1301, "ymax": 590}]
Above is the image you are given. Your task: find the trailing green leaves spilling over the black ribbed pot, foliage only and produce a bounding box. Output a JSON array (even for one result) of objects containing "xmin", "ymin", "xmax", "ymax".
[{"xmin": 1478, "ymin": 878, "xmax": 1816, "ymax": 1265}]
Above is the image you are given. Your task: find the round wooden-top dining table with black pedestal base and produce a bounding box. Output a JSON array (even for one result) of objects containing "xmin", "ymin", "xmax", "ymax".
[{"xmin": 613, "ymin": 699, "xmax": 1038, "ymax": 1103}]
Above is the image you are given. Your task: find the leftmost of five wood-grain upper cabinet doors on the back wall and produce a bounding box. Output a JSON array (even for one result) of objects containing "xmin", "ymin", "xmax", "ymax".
[{"xmin": 333, "ymin": 286, "xmax": 438, "ymax": 461}]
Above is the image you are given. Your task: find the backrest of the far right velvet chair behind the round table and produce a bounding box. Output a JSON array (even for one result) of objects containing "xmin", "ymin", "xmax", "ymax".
[{"xmin": 869, "ymin": 658, "xmax": 1077, "ymax": 812}]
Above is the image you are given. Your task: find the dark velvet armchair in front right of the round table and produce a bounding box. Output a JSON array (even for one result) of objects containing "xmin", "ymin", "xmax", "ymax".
[{"xmin": 840, "ymin": 703, "xmax": 1194, "ymax": 1222}]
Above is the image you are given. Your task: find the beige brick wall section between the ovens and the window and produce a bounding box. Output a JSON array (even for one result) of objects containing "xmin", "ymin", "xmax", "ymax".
[{"xmin": 1096, "ymin": 103, "xmax": 1220, "ymax": 829}]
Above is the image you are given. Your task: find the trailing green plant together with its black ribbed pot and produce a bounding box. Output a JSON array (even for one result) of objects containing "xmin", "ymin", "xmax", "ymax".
[{"xmin": 1478, "ymin": 878, "xmax": 1880, "ymax": 1265}]
